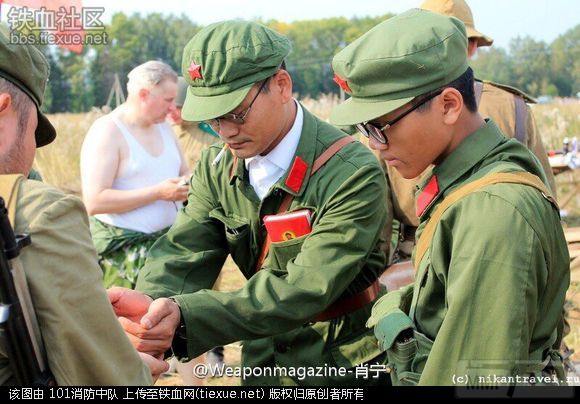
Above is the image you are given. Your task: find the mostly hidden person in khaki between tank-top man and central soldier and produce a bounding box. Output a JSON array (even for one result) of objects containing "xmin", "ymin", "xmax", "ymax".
[{"xmin": 167, "ymin": 77, "xmax": 219, "ymax": 170}]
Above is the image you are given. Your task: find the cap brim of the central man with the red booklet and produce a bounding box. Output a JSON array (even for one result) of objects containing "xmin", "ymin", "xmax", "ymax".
[{"xmin": 181, "ymin": 83, "xmax": 254, "ymax": 122}]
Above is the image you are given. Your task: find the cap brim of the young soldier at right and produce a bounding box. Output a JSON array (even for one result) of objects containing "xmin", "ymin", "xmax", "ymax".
[{"xmin": 330, "ymin": 97, "xmax": 415, "ymax": 126}]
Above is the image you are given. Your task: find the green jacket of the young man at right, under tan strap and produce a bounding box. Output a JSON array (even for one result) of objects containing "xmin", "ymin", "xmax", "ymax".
[{"xmin": 369, "ymin": 121, "xmax": 570, "ymax": 385}]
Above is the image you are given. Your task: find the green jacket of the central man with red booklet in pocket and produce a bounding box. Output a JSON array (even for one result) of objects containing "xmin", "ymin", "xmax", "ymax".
[{"xmin": 137, "ymin": 105, "xmax": 388, "ymax": 384}]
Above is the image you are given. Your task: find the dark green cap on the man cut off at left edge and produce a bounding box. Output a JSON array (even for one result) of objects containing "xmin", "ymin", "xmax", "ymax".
[{"xmin": 0, "ymin": 30, "xmax": 56, "ymax": 147}]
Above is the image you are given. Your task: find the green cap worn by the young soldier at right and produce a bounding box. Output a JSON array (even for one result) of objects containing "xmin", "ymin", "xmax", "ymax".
[{"xmin": 330, "ymin": 9, "xmax": 469, "ymax": 125}]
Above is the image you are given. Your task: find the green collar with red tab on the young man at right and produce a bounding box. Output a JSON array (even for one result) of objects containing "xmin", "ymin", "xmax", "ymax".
[{"xmin": 417, "ymin": 119, "xmax": 505, "ymax": 216}]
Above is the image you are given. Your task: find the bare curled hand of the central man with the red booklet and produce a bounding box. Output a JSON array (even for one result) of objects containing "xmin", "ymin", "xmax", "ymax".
[{"xmin": 119, "ymin": 298, "xmax": 181, "ymax": 356}]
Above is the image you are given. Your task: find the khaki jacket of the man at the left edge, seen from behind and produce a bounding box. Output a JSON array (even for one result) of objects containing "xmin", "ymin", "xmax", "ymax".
[{"xmin": 0, "ymin": 180, "xmax": 152, "ymax": 386}]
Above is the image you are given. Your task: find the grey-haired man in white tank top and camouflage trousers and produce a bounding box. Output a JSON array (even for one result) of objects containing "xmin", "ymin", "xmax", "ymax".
[{"xmin": 81, "ymin": 61, "xmax": 190, "ymax": 287}]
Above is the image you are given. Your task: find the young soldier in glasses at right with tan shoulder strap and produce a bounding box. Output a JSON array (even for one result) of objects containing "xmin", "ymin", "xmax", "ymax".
[{"xmin": 331, "ymin": 9, "xmax": 570, "ymax": 385}]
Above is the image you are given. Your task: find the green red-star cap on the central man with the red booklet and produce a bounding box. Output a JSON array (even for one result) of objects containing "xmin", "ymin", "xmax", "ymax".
[{"xmin": 181, "ymin": 21, "xmax": 291, "ymax": 121}]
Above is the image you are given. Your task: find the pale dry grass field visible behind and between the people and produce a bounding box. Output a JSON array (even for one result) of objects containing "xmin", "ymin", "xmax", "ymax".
[{"xmin": 35, "ymin": 96, "xmax": 580, "ymax": 385}]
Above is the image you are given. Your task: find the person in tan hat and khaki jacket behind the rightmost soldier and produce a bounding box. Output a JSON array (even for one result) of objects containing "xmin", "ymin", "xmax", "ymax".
[{"xmin": 386, "ymin": 0, "xmax": 556, "ymax": 258}]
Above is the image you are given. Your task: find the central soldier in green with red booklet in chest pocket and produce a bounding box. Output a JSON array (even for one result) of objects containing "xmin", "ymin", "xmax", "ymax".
[{"xmin": 110, "ymin": 21, "xmax": 388, "ymax": 385}]
